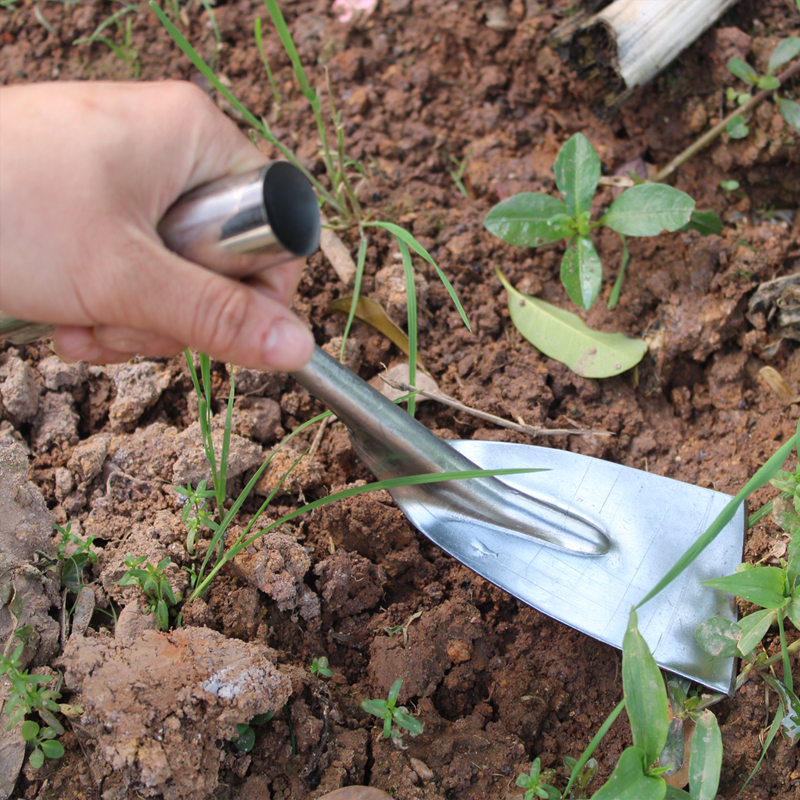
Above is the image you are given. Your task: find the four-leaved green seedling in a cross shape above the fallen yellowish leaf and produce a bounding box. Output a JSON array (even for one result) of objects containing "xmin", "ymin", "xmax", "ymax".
[{"xmin": 484, "ymin": 133, "xmax": 694, "ymax": 309}]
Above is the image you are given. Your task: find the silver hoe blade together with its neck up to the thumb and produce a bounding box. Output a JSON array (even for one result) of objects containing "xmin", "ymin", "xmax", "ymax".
[{"xmin": 293, "ymin": 350, "xmax": 746, "ymax": 693}]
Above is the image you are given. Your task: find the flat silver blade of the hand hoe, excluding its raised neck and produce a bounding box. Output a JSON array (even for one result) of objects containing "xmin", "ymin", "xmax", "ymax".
[{"xmin": 393, "ymin": 441, "xmax": 746, "ymax": 694}]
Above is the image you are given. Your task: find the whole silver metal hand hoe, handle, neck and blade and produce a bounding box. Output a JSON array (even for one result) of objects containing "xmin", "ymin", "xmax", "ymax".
[{"xmin": 0, "ymin": 162, "xmax": 745, "ymax": 693}]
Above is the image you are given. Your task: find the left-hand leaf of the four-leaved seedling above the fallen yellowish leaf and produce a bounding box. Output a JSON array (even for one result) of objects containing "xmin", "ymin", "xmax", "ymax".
[{"xmin": 483, "ymin": 192, "xmax": 571, "ymax": 247}]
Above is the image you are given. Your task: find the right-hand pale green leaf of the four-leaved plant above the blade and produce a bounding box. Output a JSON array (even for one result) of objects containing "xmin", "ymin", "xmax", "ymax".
[{"xmin": 600, "ymin": 183, "xmax": 694, "ymax": 236}]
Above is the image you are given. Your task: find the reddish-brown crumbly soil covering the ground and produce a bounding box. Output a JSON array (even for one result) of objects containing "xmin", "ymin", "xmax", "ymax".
[{"xmin": 0, "ymin": 0, "xmax": 800, "ymax": 800}]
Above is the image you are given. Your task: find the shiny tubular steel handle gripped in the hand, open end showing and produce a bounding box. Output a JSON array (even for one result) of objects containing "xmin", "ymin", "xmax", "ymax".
[{"xmin": 0, "ymin": 161, "xmax": 320, "ymax": 344}]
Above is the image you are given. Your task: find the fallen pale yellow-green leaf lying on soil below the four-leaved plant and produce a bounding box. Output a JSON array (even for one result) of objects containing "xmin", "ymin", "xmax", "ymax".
[{"xmin": 496, "ymin": 270, "xmax": 647, "ymax": 378}]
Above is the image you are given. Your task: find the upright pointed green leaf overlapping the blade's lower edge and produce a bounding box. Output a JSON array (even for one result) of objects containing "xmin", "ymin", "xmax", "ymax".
[{"xmin": 622, "ymin": 608, "xmax": 669, "ymax": 764}]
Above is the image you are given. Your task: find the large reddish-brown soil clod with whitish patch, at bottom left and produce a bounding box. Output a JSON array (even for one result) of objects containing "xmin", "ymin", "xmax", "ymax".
[{"xmin": 61, "ymin": 628, "xmax": 292, "ymax": 800}]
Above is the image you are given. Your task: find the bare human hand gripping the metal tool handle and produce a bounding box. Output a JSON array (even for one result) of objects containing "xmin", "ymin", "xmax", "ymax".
[{"xmin": 0, "ymin": 81, "xmax": 314, "ymax": 371}]
